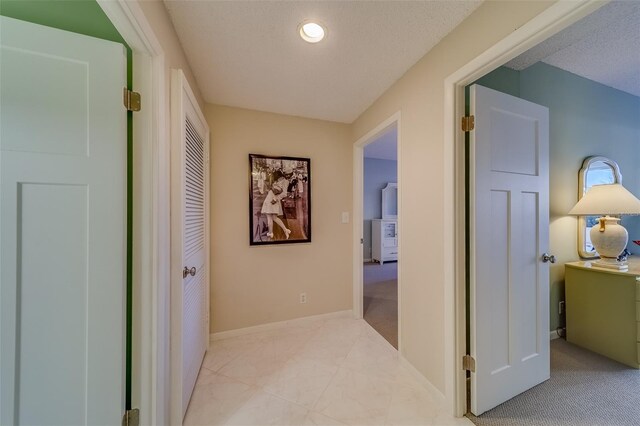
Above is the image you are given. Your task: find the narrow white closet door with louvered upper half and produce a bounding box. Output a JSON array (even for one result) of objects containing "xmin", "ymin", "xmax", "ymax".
[{"xmin": 171, "ymin": 70, "xmax": 209, "ymax": 424}]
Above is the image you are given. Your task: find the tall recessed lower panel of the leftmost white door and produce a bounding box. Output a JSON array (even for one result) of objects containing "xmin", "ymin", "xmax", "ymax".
[{"xmin": 16, "ymin": 184, "xmax": 90, "ymax": 424}]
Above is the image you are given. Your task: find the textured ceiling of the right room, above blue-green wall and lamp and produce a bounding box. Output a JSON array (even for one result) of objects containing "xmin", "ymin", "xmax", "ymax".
[{"xmin": 506, "ymin": 0, "xmax": 640, "ymax": 96}]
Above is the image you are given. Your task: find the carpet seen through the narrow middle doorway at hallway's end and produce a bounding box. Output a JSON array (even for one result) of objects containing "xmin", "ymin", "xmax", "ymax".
[{"xmin": 363, "ymin": 262, "xmax": 398, "ymax": 349}]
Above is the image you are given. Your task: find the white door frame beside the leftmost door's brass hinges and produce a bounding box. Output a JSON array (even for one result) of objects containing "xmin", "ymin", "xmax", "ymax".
[{"xmin": 97, "ymin": 0, "xmax": 170, "ymax": 425}]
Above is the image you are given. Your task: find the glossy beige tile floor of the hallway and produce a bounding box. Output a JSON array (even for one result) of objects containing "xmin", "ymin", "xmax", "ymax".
[{"xmin": 184, "ymin": 317, "xmax": 472, "ymax": 426}]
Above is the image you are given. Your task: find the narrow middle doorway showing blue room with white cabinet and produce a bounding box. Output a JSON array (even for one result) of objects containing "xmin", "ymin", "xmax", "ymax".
[{"xmin": 353, "ymin": 112, "xmax": 402, "ymax": 349}]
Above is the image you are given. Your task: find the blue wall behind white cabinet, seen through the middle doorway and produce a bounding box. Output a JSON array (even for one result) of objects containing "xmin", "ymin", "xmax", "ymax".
[{"xmin": 363, "ymin": 158, "xmax": 398, "ymax": 259}]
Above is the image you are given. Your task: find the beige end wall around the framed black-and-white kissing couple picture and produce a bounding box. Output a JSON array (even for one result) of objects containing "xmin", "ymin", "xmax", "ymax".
[{"xmin": 205, "ymin": 105, "xmax": 352, "ymax": 333}]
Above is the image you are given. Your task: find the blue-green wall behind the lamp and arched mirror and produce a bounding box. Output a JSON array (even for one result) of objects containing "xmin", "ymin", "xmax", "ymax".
[{"xmin": 476, "ymin": 62, "xmax": 640, "ymax": 330}]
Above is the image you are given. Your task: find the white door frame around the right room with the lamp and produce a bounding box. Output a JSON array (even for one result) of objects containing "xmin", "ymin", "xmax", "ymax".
[{"xmin": 443, "ymin": 0, "xmax": 607, "ymax": 417}]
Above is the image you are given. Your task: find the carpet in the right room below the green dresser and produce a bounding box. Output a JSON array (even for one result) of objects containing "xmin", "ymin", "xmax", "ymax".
[{"xmin": 469, "ymin": 338, "xmax": 640, "ymax": 426}]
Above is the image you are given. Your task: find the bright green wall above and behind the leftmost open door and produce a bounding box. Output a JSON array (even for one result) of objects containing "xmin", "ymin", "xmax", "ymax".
[{"xmin": 0, "ymin": 0, "xmax": 133, "ymax": 409}]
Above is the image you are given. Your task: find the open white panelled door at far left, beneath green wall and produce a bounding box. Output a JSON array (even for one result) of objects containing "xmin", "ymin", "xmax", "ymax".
[{"xmin": 0, "ymin": 17, "xmax": 127, "ymax": 425}]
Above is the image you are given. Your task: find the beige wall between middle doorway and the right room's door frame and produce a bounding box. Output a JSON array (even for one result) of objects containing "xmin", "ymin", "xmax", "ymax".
[{"xmin": 353, "ymin": 1, "xmax": 553, "ymax": 392}]
